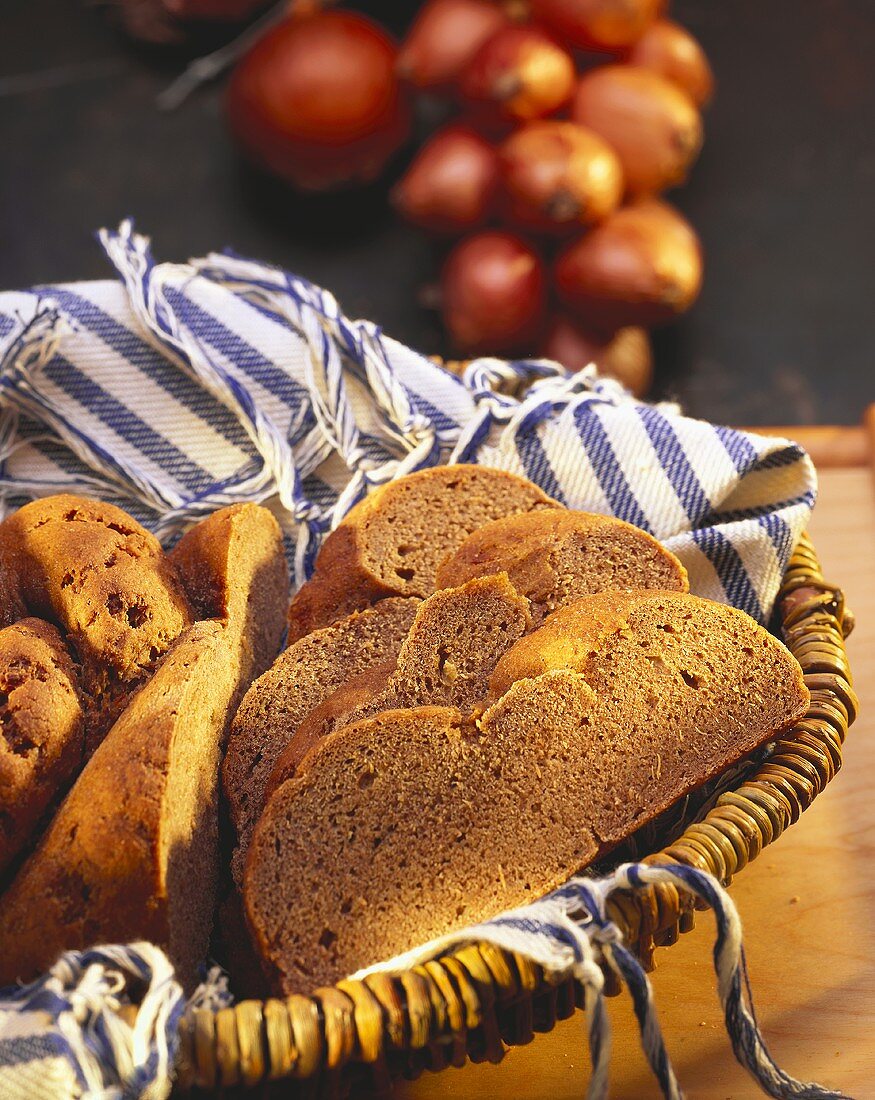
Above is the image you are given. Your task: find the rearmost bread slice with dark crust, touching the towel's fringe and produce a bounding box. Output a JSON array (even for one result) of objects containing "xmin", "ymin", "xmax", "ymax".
[{"xmin": 288, "ymin": 465, "xmax": 558, "ymax": 641}]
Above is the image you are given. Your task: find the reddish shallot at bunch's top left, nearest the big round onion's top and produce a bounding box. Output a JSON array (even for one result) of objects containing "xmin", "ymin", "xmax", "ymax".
[{"xmin": 396, "ymin": 0, "xmax": 507, "ymax": 92}]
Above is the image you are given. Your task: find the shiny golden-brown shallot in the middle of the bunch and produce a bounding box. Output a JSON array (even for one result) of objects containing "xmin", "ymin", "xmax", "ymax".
[{"xmin": 500, "ymin": 120, "xmax": 623, "ymax": 232}]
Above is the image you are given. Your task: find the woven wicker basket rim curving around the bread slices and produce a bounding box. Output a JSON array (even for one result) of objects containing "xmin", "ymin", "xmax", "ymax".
[{"xmin": 177, "ymin": 537, "xmax": 857, "ymax": 1096}]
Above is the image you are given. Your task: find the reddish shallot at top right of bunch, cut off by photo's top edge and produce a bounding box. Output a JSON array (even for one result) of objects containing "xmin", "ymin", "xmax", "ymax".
[{"xmin": 532, "ymin": 0, "xmax": 661, "ymax": 53}]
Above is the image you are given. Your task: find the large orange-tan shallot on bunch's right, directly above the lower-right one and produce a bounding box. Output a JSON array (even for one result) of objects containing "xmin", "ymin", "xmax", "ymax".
[{"xmin": 571, "ymin": 65, "xmax": 702, "ymax": 196}]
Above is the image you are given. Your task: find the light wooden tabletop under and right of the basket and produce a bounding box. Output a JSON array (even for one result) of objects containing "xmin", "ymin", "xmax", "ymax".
[{"xmin": 396, "ymin": 466, "xmax": 875, "ymax": 1100}]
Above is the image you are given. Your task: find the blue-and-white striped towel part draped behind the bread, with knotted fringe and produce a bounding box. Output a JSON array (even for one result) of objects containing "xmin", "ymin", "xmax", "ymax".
[{"xmin": 0, "ymin": 222, "xmax": 816, "ymax": 622}]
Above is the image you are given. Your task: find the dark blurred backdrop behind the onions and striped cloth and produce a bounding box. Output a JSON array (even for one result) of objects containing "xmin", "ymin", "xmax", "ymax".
[{"xmin": 0, "ymin": 0, "xmax": 875, "ymax": 424}]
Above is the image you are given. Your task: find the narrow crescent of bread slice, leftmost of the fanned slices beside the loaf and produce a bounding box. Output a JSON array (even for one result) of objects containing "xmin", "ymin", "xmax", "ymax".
[{"xmin": 222, "ymin": 598, "xmax": 419, "ymax": 882}]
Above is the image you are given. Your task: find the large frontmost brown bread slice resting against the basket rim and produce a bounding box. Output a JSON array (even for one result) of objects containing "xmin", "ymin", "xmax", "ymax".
[{"xmin": 244, "ymin": 592, "xmax": 808, "ymax": 993}]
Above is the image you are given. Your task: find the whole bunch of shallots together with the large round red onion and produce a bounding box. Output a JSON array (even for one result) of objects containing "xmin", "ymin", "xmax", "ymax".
[{"xmin": 228, "ymin": 0, "xmax": 713, "ymax": 393}]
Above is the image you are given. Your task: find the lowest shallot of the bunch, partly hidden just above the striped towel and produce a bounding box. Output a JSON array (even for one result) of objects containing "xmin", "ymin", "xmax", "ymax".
[{"xmin": 540, "ymin": 314, "xmax": 653, "ymax": 397}]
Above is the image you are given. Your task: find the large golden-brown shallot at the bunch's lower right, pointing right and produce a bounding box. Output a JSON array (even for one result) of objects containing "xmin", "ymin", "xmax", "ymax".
[{"xmin": 555, "ymin": 199, "xmax": 702, "ymax": 332}]
